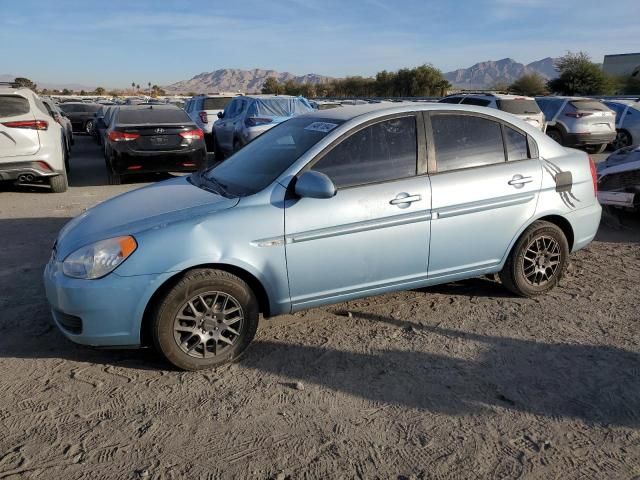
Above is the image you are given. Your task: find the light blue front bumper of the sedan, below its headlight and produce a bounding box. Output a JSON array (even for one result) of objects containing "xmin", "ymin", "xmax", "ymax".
[{"xmin": 44, "ymin": 260, "xmax": 170, "ymax": 347}]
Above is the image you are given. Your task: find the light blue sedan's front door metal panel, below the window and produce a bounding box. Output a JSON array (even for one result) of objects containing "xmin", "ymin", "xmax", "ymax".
[{"xmin": 285, "ymin": 176, "xmax": 431, "ymax": 309}]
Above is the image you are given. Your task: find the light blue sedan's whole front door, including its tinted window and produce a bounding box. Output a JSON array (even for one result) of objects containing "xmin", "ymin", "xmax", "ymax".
[{"xmin": 285, "ymin": 115, "xmax": 431, "ymax": 310}]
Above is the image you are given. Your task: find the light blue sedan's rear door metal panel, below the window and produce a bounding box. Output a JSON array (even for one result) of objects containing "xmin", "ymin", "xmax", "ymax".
[{"xmin": 429, "ymin": 159, "xmax": 542, "ymax": 277}]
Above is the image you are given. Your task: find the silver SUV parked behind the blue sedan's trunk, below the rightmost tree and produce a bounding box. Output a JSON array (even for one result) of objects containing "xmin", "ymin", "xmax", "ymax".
[{"xmin": 536, "ymin": 97, "xmax": 616, "ymax": 153}]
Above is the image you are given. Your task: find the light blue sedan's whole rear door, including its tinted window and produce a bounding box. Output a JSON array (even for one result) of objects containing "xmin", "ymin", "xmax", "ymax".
[{"xmin": 426, "ymin": 112, "xmax": 542, "ymax": 278}]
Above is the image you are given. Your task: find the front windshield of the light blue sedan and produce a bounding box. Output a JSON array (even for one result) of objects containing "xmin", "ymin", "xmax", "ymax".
[{"xmin": 203, "ymin": 116, "xmax": 343, "ymax": 196}]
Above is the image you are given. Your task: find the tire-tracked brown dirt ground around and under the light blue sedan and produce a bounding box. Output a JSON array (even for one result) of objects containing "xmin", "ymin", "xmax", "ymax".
[{"xmin": 0, "ymin": 138, "xmax": 640, "ymax": 479}]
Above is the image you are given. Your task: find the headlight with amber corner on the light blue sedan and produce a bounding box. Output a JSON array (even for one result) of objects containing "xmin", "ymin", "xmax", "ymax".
[{"xmin": 62, "ymin": 236, "xmax": 138, "ymax": 280}]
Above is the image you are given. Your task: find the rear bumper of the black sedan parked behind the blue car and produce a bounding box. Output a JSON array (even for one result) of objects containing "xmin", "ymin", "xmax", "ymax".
[{"xmin": 111, "ymin": 148, "xmax": 207, "ymax": 175}]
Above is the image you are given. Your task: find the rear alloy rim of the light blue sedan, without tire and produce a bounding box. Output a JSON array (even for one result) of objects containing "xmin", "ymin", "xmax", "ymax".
[{"xmin": 522, "ymin": 235, "xmax": 562, "ymax": 287}]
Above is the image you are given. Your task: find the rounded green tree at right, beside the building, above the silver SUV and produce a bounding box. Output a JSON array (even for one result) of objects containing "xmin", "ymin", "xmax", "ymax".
[{"xmin": 548, "ymin": 52, "xmax": 616, "ymax": 95}]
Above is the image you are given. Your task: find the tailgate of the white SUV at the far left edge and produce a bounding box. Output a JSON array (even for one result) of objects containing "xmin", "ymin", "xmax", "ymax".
[{"xmin": 0, "ymin": 94, "xmax": 40, "ymax": 158}]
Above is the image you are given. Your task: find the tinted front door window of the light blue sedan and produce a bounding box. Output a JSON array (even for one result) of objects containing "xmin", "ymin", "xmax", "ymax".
[{"xmin": 313, "ymin": 116, "xmax": 417, "ymax": 188}]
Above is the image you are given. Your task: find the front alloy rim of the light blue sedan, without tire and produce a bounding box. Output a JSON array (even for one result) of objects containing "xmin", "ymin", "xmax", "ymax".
[{"xmin": 173, "ymin": 292, "xmax": 245, "ymax": 358}]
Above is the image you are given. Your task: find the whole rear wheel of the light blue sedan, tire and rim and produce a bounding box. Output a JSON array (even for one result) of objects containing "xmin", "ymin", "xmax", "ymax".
[{"xmin": 499, "ymin": 221, "xmax": 569, "ymax": 297}]
